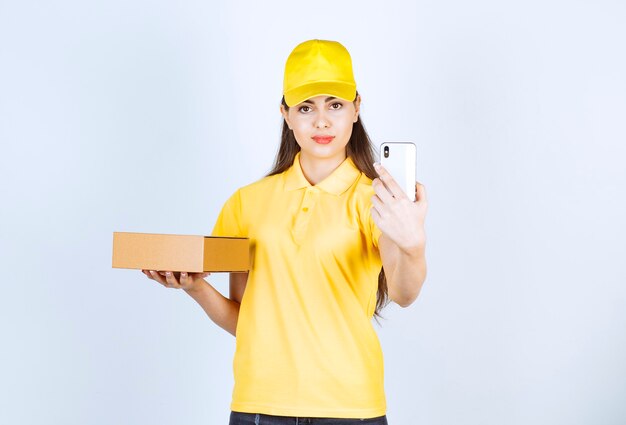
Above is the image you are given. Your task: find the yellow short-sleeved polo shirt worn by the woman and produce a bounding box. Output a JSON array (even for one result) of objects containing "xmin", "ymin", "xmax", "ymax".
[{"xmin": 212, "ymin": 152, "xmax": 386, "ymax": 418}]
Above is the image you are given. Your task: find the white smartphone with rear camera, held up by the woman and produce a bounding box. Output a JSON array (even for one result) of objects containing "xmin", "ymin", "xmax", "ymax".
[{"xmin": 380, "ymin": 141, "xmax": 417, "ymax": 202}]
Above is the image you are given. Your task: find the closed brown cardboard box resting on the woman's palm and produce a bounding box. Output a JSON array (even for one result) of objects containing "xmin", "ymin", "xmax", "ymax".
[{"xmin": 113, "ymin": 232, "xmax": 250, "ymax": 273}]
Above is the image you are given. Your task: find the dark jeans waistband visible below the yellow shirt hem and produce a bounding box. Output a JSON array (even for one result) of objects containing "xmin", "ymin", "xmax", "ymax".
[{"xmin": 228, "ymin": 411, "xmax": 388, "ymax": 425}]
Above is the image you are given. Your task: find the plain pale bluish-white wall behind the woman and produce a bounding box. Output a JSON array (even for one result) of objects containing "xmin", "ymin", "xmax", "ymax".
[{"xmin": 0, "ymin": 0, "xmax": 626, "ymax": 425}]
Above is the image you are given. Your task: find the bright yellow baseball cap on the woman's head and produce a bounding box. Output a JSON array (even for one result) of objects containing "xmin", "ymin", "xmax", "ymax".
[{"xmin": 283, "ymin": 39, "xmax": 356, "ymax": 107}]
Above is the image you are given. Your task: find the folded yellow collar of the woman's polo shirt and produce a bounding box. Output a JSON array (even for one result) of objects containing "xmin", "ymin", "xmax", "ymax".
[{"xmin": 284, "ymin": 151, "xmax": 361, "ymax": 195}]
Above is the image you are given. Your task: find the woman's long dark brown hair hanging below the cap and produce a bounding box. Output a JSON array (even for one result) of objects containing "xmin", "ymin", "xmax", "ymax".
[{"xmin": 266, "ymin": 91, "xmax": 389, "ymax": 325}]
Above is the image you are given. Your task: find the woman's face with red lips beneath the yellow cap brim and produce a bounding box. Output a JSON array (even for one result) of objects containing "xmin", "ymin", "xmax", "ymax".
[{"xmin": 280, "ymin": 95, "xmax": 361, "ymax": 159}]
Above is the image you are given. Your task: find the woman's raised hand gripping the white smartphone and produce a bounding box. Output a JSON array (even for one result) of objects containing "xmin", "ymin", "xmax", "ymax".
[{"xmin": 371, "ymin": 161, "xmax": 428, "ymax": 253}]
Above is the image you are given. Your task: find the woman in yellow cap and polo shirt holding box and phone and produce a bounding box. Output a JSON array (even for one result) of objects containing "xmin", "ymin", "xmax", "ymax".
[{"xmin": 144, "ymin": 40, "xmax": 427, "ymax": 425}]
